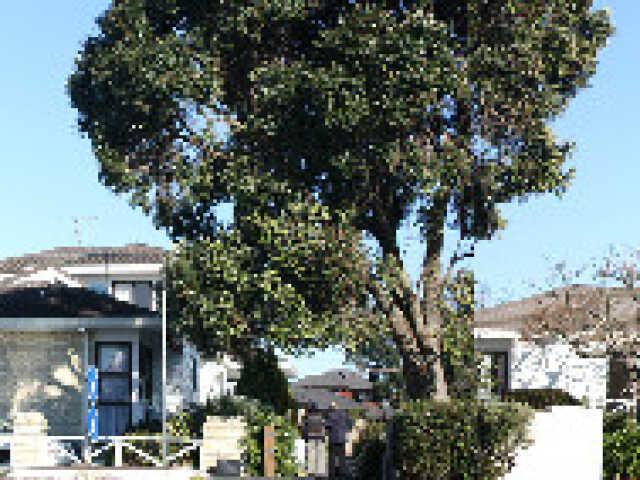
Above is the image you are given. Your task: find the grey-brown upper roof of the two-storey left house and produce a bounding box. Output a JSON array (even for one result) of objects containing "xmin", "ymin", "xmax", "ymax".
[{"xmin": 0, "ymin": 243, "xmax": 168, "ymax": 274}]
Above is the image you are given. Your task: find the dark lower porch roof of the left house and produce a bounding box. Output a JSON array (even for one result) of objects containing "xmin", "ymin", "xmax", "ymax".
[{"xmin": 0, "ymin": 283, "xmax": 157, "ymax": 316}]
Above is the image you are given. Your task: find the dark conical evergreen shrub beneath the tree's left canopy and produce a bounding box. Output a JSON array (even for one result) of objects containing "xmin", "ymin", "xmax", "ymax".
[{"xmin": 236, "ymin": 344, "xmax": 297, "ymax": 415}]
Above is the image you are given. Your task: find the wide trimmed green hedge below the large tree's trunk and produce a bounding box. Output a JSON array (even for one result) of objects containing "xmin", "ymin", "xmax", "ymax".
[{"xmin": 394, "ymin": 400, "xmax": 531, "ymax": 480}]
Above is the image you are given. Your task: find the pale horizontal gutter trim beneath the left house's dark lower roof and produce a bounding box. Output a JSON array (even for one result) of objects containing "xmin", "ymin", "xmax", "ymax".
[{"xmin": 0, "ymin": 316, "xmax": 162, "ymax": 331}]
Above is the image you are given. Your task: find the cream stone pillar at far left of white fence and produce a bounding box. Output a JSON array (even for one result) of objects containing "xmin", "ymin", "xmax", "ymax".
[{"xmin": 11, "ymin": 412, "xmax": 54, "ymax": 469}]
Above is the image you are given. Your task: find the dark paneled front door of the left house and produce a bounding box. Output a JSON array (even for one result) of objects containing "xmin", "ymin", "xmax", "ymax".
[{"xmin": 96, "ymin": 342, "xmax": 131, "ymax": 435}]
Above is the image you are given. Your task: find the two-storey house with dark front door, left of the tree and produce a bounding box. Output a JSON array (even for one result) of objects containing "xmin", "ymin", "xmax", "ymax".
[{"xmin": 0, "ymin": 244, "xmax": 295, "ymax": 464}]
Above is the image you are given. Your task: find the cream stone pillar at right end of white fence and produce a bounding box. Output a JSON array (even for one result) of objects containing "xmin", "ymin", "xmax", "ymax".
[{"xmin": 200, "ymin": 417, "xmax": 247, "ymax": 472}]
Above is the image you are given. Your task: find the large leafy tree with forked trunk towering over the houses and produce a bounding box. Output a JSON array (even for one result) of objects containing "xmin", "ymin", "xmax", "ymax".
[{"xmin": 69, "ymin": 0, "xmax": 612, "ymax": 399}]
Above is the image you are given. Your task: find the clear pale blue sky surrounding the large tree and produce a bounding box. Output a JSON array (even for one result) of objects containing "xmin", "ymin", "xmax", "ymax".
[{"xmin": 0, "ymin": 0, "xmax": 640, "ymax": 380}]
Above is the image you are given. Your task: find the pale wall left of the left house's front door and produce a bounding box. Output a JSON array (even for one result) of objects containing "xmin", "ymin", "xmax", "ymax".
[{"xmin": 0, "ymin": 332, "xmax": 86, "ymax": 435}]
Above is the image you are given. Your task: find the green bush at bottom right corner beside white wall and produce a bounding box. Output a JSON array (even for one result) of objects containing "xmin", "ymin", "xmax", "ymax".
[{"xmin": 602, "ymin": 412, "xmax": 640, "ymax": 480}]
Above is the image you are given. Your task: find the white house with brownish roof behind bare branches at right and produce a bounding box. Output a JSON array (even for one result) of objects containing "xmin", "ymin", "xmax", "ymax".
[{"xmin": 474, "ymin": 285, "xmax": 640, "ymax": 408}]
